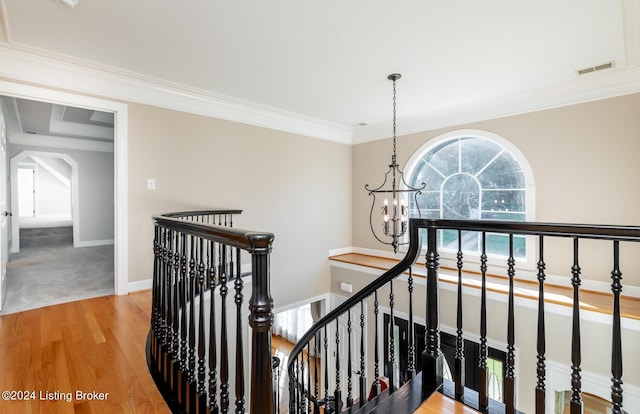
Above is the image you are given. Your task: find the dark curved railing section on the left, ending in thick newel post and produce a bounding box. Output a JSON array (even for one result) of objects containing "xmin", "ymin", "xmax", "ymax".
[{"xmin": 147, "ymin": 210, "xmax": 275, "ymax": 413}]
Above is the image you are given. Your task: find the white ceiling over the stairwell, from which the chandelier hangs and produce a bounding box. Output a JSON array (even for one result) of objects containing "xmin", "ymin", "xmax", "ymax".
[{"xmin": 0, "ymin": 0, "xmax": 640, "ymax": 142}]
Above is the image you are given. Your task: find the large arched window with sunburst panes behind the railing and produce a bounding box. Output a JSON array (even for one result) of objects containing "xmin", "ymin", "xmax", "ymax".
[{"xmin": 407, "ymin": 130, "xmax": 534, "ymax": 259}]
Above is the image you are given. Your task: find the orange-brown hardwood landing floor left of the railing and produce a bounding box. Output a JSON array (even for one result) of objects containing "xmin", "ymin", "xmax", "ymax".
[{"xmin": 0, "ymin": 291, "xmax": 169, "ymax": 414}]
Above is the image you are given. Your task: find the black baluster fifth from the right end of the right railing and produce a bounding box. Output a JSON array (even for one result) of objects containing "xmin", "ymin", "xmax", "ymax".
[{"xmin": 478, "ymin": 232, "xmax": 489, "ymax": 412}]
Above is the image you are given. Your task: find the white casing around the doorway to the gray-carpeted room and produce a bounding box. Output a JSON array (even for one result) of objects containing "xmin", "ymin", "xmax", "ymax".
[{"xmin": 0, "ymin": 81, "xmax": 129, "ymax": 314}]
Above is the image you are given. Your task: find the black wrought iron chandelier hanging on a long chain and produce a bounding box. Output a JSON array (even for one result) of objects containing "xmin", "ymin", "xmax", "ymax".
[{"xmin": 364, "ymin": 73, "xmax": 426, "ymax": 253}]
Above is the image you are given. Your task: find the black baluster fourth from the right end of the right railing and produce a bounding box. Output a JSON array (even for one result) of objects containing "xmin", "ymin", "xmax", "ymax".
[{"xmin": 504, "ymin": 234, "xmax": 516, "ymax": 414}]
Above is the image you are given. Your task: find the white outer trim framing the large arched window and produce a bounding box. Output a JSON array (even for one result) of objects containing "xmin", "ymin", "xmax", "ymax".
[{"xmin": 404, "ymin": 129, "xmax": 537, "ymax": 273}]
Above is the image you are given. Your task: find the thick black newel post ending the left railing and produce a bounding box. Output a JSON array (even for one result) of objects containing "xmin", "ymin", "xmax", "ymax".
[{"xmin": 249, "ymin": 234, "xmax": 274, "ymax": 413}]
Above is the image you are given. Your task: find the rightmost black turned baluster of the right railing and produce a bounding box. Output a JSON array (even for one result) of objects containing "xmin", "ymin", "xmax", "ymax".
[{"xmin": 611, "ymin": 240, "xmax": 623, "ymax": 414}]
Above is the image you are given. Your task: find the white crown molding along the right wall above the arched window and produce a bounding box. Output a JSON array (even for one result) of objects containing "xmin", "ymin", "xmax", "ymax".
[{"xmin": 352, "ymin": 67, "xmax": 640, "ymax": 144}]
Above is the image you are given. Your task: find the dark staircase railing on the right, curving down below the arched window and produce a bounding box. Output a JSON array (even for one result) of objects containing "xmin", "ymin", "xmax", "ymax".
[{"xmin": 288, "ymin": 219, "xmax": 640, "ymax": 414}]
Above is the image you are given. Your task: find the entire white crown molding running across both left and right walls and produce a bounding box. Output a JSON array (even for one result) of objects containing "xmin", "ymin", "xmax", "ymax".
[{"xmin": 0, "ymin": 45, "xmax": 640, "ymax": 144}]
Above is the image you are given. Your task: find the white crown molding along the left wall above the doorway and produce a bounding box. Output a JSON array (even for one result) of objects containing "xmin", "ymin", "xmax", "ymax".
[{"xmin": 0, "ymin": 45, "xmax": 353, "ymax": 144}]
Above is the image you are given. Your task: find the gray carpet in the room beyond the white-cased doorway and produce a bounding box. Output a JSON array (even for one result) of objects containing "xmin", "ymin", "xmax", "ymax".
[{"xmin": 0, "ymin": 244, "xmax": 114, "ymax": 315}]
